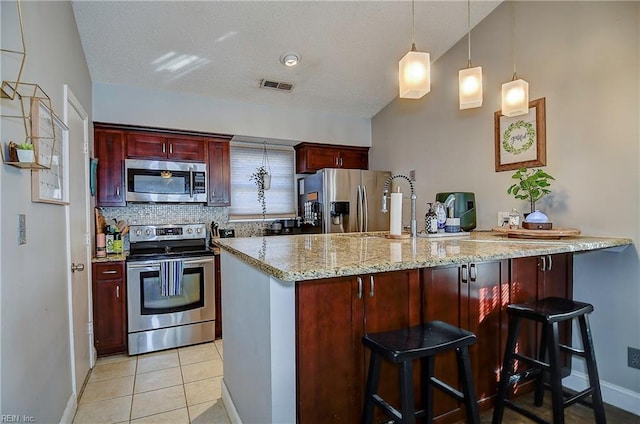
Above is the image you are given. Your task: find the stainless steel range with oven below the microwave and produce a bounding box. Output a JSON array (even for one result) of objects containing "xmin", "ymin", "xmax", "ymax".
[{"xmin": 127, "ymin": 224, "xmax": 216, "ymax": 355}]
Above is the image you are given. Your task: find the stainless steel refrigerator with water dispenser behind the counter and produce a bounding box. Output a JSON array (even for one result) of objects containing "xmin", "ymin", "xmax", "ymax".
[{"xmin": 298, "ymin": 168, "xmax": 391, "ymax": 233}]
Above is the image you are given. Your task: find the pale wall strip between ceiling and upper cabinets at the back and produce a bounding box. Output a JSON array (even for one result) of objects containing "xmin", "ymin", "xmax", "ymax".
[{"xmin": 93, "ymin": 82, "xmax": 371, "ymax": 146}]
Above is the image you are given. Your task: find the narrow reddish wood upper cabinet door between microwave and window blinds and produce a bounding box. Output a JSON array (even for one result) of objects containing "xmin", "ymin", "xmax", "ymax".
[{"xmin": 207, "ymin": 140, "xmax": 231, "ymax": 206}]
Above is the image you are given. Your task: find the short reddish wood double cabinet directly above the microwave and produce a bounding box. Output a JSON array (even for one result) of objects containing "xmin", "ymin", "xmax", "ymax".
[{"xmin": 127, "ymin": 132, "xmax": 206, "ymax": 162}]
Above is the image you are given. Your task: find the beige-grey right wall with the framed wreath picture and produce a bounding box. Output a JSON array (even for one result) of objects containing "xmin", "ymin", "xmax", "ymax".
[{"xmin": 370, "ymin": 2, "xmax": 640, "ymax": 408}]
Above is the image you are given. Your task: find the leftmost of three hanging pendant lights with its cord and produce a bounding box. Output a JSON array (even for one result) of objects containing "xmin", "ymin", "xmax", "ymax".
[{"xmin": 398, "ymin": 0, "xmax": 431, "ymax": 99}]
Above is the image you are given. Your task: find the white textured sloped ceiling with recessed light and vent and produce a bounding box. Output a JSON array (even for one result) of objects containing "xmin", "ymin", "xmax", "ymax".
[{"xmin": 72, "ymin": 0, "xmax": 501, "ymax": 117}]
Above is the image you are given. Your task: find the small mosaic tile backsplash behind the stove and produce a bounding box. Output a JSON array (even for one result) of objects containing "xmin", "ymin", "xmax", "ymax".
[{"xmin": 99, "ymin": 203, "xmax": 267, "ymax": 237}]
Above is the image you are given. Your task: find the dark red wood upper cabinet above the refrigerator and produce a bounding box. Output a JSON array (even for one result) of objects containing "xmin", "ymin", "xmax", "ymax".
[{"xmin": 295, "ymin": 143, "xmax": 369, "ymax": 174}]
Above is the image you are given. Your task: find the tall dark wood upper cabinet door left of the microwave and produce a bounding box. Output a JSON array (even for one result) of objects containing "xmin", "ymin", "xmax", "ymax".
[{"xmin": 94, "ymin": 128, "xmax": 126, "ymax": 206}]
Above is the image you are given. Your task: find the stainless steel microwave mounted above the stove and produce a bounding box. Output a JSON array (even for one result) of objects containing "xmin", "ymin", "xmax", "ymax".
[{"xmin": 124, "ymin": 159, "xmax": 207, "ymax": 203}]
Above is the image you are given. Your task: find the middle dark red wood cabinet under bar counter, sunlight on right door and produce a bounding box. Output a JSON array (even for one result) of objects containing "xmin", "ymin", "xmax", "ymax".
[{"xmin": 422, "ymin": 261, "xmax": 508, "ymax": 422}]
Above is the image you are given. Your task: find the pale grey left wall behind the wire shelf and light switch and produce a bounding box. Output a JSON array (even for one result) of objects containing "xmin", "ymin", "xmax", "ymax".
[{"xmin": 0, "ymin": 1, "xmax": 91, "ymax": 422}]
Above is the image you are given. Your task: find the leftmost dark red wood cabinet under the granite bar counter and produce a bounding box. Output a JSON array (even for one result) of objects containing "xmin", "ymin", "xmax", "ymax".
[{"xmin": 296, "ymin": 270, "xmax": 420, "ymax": 423}]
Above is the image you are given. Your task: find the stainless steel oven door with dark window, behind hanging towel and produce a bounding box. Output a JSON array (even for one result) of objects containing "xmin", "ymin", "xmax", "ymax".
[{"xmin": 127, "ymin": 256, "xmax": 215, "ymax": 333}]
